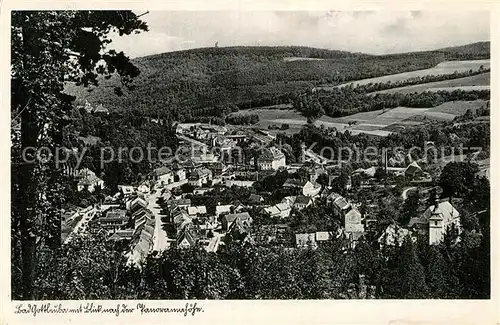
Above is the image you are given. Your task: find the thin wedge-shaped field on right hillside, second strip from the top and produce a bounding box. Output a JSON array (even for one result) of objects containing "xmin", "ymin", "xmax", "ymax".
[{"xmin": 372, "ymin": 72, "xmax": 490, "ymax": 94}]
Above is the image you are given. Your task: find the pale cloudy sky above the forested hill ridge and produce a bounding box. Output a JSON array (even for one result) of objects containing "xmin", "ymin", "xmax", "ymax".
[{"xmin": 110, "ymin": 10, "xmax": 490, "ymax": 57}]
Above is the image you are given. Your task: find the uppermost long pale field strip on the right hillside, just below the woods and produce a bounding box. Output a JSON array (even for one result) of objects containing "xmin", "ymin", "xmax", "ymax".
[{"xmin": 316, "ymin": 60, "xmax": 490, "ymax": 90}]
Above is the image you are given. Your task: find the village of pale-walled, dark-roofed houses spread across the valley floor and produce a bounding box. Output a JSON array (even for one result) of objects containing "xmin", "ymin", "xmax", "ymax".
[{"xmin": 62, "ymin": 114, "xmax": 484, "ymax": 266}]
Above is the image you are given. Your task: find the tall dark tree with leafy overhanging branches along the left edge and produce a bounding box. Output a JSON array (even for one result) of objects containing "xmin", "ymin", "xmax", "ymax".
[{"xmin": 11, "ymin": 11, "xmax": 147, "ymax": 299}]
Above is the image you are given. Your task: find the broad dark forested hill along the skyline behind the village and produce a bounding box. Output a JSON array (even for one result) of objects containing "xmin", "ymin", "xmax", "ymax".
[{"xmin": 67, "ymin": 42, "xmax": 490, "ymax": 119}]
